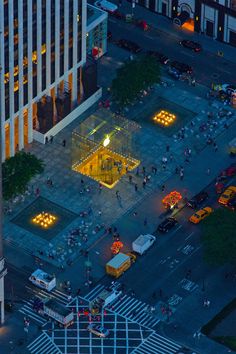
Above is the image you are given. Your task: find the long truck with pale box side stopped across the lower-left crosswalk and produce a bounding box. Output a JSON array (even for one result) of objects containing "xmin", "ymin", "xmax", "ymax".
[{"xmin": 33, "ymin": 298, "xmax": 74, "ymax": 328}]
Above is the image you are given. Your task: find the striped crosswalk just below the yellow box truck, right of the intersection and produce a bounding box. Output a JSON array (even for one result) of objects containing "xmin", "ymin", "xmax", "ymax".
[{"xmin": 84, "ymin": 282, "xmax": 160, "ymax": 329}]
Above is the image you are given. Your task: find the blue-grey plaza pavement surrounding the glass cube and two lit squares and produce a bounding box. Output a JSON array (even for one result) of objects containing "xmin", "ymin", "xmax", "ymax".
[{"xmin": 4, "ymin": 75, "xmax": 235, "ymax": 272}]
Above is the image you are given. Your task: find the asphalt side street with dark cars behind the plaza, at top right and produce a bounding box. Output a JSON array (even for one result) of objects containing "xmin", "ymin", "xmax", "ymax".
[{"xmin": 108, "ymin": 17, "xmax": 236, "ymax": 86}]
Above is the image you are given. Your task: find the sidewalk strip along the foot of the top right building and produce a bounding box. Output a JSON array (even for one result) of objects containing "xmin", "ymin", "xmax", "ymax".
[{"xmin": 109, "ymin": 0, "xmax": 236, "ymax": 62}]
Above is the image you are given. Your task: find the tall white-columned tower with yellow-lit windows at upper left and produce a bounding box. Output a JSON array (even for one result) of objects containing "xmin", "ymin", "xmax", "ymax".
[{"xmin": 0, "ymin": 0, "xmax": 100, "ymax": 159}]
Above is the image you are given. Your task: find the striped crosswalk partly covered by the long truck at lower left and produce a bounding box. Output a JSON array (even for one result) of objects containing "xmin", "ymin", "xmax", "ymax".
[{"xmin": 18, "ymin": 288, "xmax": 68, "ymax": 326}]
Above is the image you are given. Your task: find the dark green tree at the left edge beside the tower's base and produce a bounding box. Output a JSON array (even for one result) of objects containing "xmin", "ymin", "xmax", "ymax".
[{"xmin": 2, "ymin": 152, "xmax": 44, "ymax": 200}]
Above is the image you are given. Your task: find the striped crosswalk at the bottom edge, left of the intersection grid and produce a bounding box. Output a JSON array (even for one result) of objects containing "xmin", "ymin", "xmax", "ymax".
[{"xmin": 27, "ymin": 332, "xmax": 63, "ymax": 354}]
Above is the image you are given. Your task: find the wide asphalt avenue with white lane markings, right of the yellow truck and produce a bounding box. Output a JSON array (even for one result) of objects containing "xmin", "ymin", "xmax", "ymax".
[{"xmin": 90, "ymin": 172, "xmax": 233, "ymax": 303}]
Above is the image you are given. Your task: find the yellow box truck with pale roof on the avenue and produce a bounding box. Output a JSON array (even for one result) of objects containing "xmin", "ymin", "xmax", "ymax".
[{"xmin": 106, "ymin": 253, "xmax": 131, "ymax": 278}]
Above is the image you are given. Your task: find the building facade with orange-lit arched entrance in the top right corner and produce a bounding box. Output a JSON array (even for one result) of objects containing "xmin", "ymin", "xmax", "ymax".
[{"xmin": 136, "ymin": 0, "xmax": 236, "ymax": 46}]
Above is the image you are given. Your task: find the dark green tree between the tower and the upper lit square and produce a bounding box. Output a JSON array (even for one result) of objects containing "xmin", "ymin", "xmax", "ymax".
[{"xmin": 111, "ymin": 55, "xmax": 160, "ymax": 106}]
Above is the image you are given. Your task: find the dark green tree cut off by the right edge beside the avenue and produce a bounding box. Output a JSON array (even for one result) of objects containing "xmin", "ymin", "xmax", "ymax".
[{"xmin": 202, "ymin": 208, "xmax": 236, "ymax": 265}]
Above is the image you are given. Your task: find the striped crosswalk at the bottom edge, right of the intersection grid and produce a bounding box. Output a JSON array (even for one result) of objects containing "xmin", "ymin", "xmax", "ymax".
[{"xmin": 131, "ymin": 332, "xmax": 182, "ymax": 354}]
